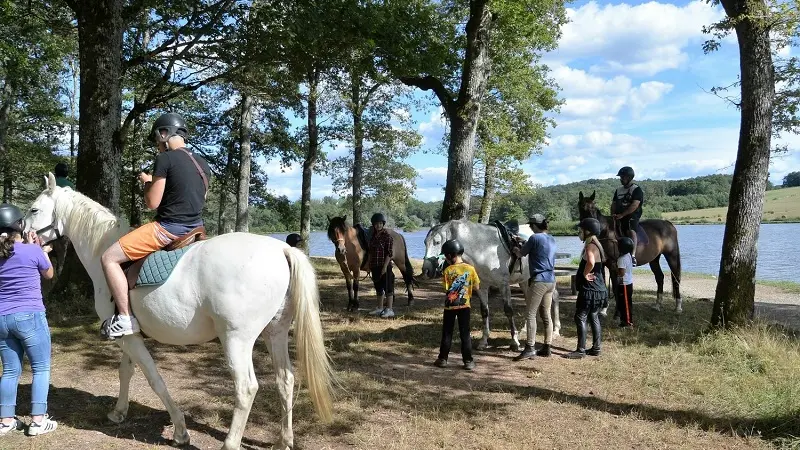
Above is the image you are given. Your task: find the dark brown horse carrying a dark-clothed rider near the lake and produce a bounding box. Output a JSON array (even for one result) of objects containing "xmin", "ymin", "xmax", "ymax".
[{"xmin": 578, "ymin": 192, "xmax": 683, "ymax": 313}]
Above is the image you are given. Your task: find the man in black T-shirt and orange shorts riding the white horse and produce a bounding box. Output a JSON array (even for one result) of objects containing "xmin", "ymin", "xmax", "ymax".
[{"xmin": 100, "ymin": 113, "xmax": 211, "ymax": 339}]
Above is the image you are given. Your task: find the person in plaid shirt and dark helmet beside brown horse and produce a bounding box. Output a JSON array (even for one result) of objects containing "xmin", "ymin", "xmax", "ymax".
[{"xmin": 368, "ymin": 213, "xmax": 394, "ymax": 319}]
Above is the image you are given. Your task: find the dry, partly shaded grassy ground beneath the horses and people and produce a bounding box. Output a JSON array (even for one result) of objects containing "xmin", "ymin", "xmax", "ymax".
[{"xmin": 0, "ymin": 258, "xmax": 800, "ymax": 450}]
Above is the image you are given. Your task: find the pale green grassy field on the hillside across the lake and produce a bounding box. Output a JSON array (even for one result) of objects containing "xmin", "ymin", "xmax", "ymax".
[{"xmin": 661, "ymin": 187, "xmax": 800, "ymax": 224}]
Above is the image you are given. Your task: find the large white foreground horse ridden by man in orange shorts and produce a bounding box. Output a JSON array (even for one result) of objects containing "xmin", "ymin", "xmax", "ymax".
[{"xmin": 26, "ymin": 174, "xmax": 333, "ymax": 449}]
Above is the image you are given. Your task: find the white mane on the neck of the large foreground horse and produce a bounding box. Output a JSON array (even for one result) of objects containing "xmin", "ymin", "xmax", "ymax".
[{"xmin": 55, "ymin": 190, "xmax": 124, "ymax": 256}]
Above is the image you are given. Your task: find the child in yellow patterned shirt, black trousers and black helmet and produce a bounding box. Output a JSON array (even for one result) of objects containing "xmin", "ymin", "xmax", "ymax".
[{"xmin": 434, "ymin": 239, "xmax": 480, "ymax": 370}]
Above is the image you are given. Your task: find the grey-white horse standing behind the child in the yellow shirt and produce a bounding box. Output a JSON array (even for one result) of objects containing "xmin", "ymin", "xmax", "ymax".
[{"xmin": 422, "ymin": 220, "xmax": 561, "ymax": 351}]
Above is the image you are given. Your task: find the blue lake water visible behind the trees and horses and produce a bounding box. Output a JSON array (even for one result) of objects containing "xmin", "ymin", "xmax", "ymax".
[{"xmin": 271, "ymin": 223, "xmax": 800, "ymax": 282}]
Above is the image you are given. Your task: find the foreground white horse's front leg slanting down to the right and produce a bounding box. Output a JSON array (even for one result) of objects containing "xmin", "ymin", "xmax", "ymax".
[{"xmin": 119, "ymin": 334, "xmax": 189, "ymax": 445}]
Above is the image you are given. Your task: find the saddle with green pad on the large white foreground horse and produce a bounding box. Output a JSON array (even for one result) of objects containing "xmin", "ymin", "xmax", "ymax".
[{"xmin": 122, "ymin": 226, "xmax": 207, "ymax": 290}]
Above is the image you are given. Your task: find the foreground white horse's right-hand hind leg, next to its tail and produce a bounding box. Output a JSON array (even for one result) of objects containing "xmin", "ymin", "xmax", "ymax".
[{"xmin": 262, "ymin": 322, "xmax": 294, "ymax": 450}]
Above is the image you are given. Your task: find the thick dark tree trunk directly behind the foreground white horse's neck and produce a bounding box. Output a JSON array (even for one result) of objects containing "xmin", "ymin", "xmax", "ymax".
[{"xmin": 75, "ymin": 0, "xmax": 124, "ymax": 214}]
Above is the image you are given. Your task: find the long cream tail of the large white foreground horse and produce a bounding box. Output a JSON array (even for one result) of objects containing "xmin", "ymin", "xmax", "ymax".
[{"xmin": 283, "ymin": 247, "xmax": 333, "ymax": 422}]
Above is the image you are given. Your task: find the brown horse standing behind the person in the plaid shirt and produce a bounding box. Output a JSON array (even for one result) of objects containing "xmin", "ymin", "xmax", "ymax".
[{"xmin": 328, "ymin": 216, "xmax": 418, "ymax": 311}]
